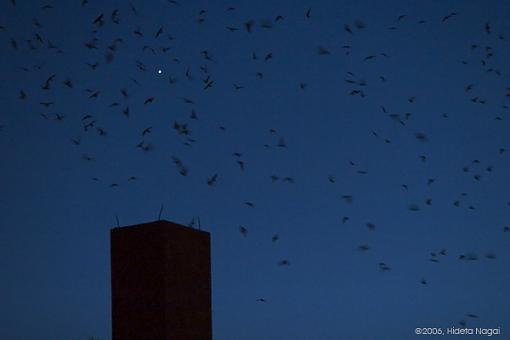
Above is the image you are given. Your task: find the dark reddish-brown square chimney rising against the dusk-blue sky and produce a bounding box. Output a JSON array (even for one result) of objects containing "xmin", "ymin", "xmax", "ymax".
[{"xmin": 110, "ymin": 220, "xmax": 212, "ymax": 340}]
